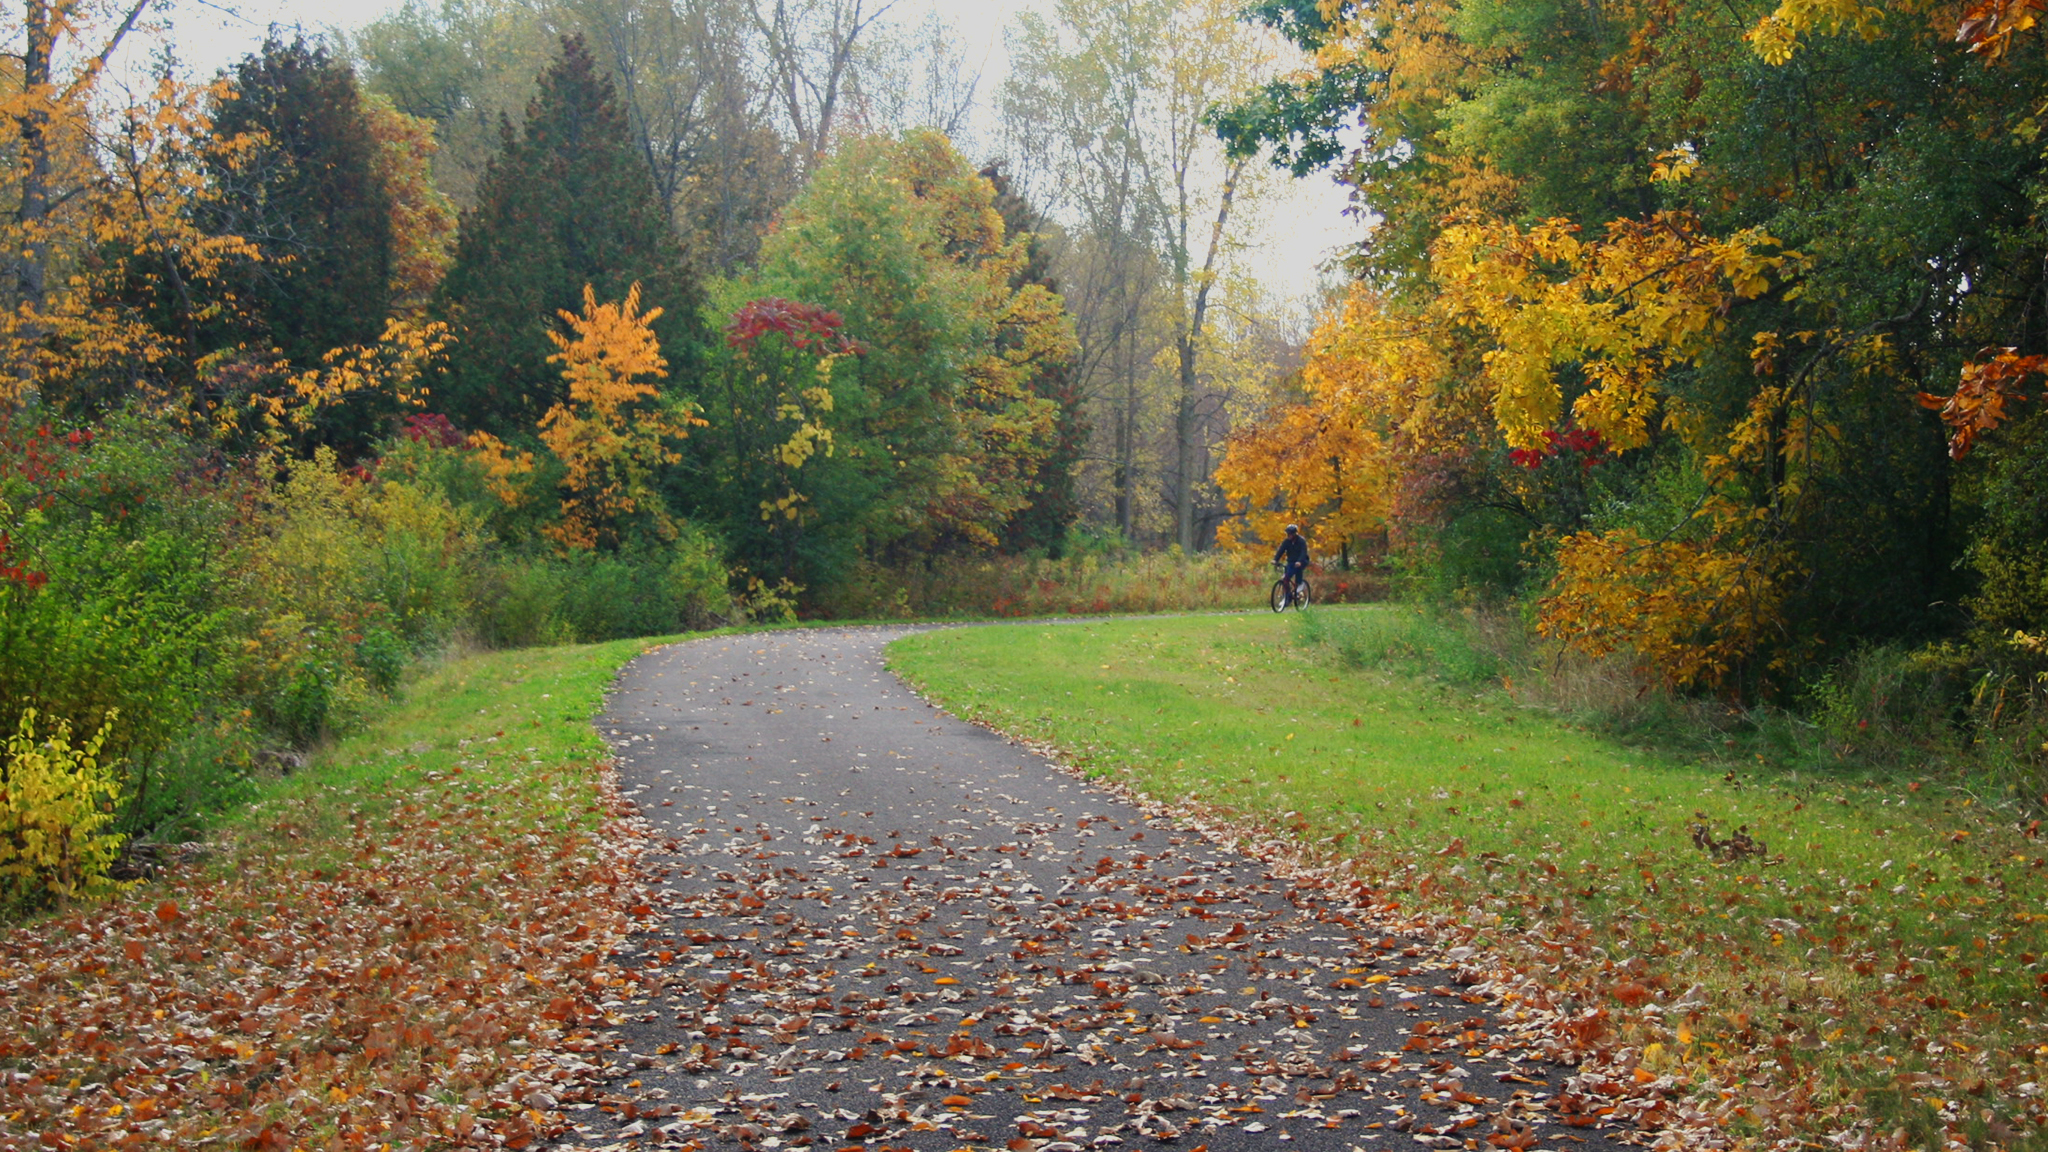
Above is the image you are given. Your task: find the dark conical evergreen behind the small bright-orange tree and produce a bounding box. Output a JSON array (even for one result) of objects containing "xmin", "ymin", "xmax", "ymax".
[{"xmin": 436, "ymin": 37, "xmax": 702, "ymax": 437}]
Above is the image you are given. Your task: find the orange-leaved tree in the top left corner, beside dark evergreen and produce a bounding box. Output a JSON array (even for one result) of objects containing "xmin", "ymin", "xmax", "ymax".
[{"xmin": 0, "ymin": 56, "xmax": 260, "ymax": 422}]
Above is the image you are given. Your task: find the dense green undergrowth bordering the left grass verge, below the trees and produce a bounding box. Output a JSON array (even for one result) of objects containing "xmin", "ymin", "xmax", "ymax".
[{"xmin": 0, "ymin": 414, "xmax": 745, "ymax": 912}]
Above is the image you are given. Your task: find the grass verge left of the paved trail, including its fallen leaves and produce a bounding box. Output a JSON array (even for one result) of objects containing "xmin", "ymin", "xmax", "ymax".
[{"xmin": 0, "ymin": 642, "xmax": 647, "ymax": 1148}]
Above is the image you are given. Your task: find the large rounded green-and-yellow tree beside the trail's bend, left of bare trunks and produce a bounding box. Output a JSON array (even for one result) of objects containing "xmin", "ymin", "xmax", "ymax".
[{"xmin": 702, "ymin": 131, "xmax": 1073, "ymax": 582}]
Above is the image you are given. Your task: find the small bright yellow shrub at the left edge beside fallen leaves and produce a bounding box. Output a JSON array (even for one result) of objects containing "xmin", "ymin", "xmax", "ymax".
[{"xmin": 0, "ymin": 709, "xmax": 121, "ymax": 908}]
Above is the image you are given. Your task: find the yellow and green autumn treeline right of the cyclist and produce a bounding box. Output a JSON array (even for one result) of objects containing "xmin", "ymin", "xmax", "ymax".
[{"xmin": 1219, "ymin": 0, "xmax": 2048, "ymax": 783}]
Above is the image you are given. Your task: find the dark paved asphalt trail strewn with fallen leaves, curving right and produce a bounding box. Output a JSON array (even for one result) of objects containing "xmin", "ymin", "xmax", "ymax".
[{"xmin": 567, "ymin": 627, "xmax": 1612, "ymax": 1152}]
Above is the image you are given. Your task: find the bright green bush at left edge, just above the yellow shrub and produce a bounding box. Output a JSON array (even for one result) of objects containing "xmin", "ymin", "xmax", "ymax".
[{"xmin": 0, "ymin": 410, "xmax": 248, "ymax": 834}]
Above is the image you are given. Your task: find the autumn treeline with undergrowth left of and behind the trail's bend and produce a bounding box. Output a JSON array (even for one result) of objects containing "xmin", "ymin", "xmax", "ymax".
[{"xmin": 0, "ymin": 0, "xmax": 1298, "ymax": 904}]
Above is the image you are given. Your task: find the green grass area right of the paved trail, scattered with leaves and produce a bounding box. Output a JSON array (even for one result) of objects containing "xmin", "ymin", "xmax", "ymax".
[{"xmin": 891, "ymin": 609, "xmax": 2048, "ymax": 1148}]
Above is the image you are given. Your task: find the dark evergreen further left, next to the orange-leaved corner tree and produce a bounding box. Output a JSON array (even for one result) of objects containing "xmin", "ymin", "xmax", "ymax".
[{"xmin": 213, "ymin": 35, "xmax": 391, "ymax": 367}]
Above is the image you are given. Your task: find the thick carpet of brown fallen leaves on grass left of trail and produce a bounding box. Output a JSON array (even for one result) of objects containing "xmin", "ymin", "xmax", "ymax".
[{"xmin": 0, "ymin": 765, "xmax": 637, "ymax": 1148}]
